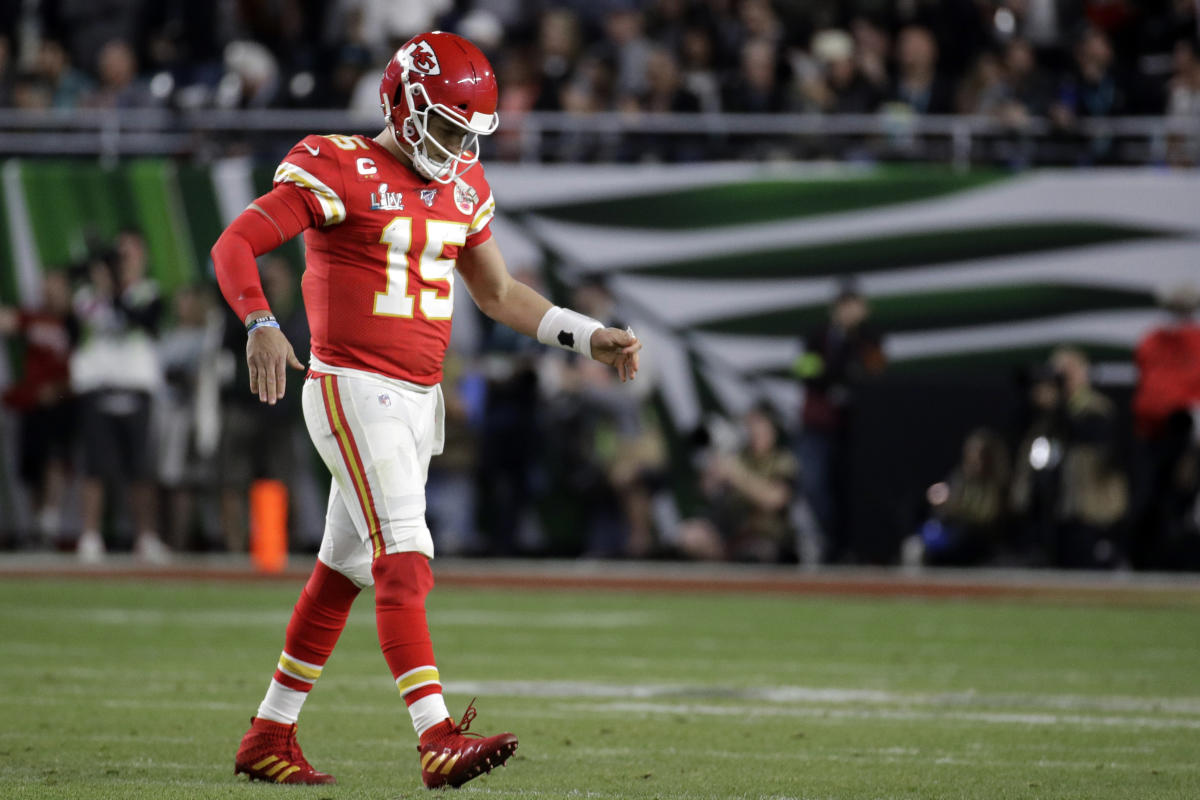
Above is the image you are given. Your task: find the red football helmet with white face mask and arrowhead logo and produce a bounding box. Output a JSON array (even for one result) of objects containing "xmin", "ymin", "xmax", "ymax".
[{"xmin": 379, "ymin": 31, "xmax": 500, "ymax": 184}]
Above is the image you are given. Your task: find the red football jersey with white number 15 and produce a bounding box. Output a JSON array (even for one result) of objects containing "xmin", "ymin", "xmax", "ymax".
[{"xmin": 275, "ymin": 136, "xmax": 496, "ymax": 386}]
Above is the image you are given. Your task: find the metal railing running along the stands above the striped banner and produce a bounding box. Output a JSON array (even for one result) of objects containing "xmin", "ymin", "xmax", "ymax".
[{"xmin": 0, "ymin": 109, "xmax": 1200, "ymax": 166}]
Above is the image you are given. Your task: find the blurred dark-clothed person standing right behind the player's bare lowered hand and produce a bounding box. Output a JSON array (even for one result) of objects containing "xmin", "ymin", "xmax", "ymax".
[{"xmin": 218, "ymin": 254, "xmax": 311, "ymax": 553}]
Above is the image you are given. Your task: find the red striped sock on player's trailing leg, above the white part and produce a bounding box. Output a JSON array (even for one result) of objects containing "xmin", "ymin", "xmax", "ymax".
[{"xmin": 275, "ymin": 561, "xmax": 360, "ymax": 692}]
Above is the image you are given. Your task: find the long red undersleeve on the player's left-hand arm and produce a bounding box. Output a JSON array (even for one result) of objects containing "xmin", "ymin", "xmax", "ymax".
[{"xmin": 211, "ymin": 184, "xmax": 314, "ymax": 320}]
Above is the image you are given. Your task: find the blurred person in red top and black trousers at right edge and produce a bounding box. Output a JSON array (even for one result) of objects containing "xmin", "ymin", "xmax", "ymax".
[{"xmin": 1129, "ymin": 287, "xmax": 1200, "ymax": 570}]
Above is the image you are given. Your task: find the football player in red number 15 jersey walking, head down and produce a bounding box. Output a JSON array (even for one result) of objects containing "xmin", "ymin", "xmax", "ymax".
[{"xmin": 212, "ymin": 32, "xmax": 641, "ymax": 788}]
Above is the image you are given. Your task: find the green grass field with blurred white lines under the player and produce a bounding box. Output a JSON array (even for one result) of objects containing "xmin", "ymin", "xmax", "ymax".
[{"xmin": 0, "ymin": 568, "xmax": 1200, "ymax": 800}]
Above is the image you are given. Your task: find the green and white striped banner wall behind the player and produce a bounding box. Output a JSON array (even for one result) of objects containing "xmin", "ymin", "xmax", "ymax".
[{"xmin": 0, "ymin": 160, "xmax": 1200, "ymax": 428}]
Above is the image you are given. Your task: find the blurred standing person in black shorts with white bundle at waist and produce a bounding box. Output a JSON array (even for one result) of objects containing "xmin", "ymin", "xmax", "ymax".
[{"xmin": 71, "ymin": 228, "xmax": 167, "ymax": 561}]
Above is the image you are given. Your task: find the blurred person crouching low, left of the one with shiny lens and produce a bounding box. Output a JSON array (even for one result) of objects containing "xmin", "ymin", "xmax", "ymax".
[{"xmin": 904, "ymin": 428, "xmax": 1010, "ymax": 566}]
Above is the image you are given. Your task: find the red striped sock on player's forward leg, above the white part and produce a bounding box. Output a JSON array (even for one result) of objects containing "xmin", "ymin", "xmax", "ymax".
[{"xmin": 371, "ymin": 553, "xmax": 442, "ymax": 705}]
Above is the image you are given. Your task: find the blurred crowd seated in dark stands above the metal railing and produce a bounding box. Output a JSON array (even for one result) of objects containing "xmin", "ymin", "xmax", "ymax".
[{"xmin": 0, "ymin": 0, "xmax": 1200, "ymax": 128}]
